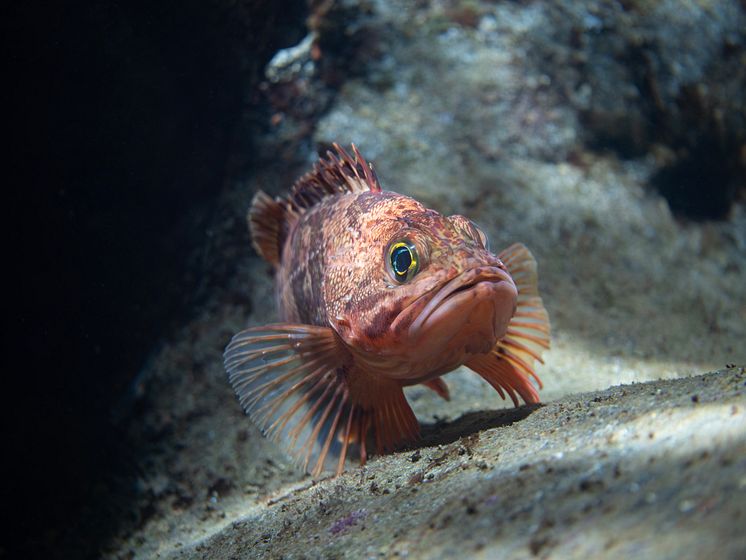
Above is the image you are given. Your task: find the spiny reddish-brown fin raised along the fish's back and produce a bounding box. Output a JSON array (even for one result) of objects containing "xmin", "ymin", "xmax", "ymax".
[{"xmin": 248, "ymin": 143, "xmax": 381, "ymax": 266}]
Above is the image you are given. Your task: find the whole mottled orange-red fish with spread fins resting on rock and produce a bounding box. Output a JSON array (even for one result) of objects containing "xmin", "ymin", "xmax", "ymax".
[{"xmin": 224, "ymin": 143, "xmax": 550, "ymax": 477}]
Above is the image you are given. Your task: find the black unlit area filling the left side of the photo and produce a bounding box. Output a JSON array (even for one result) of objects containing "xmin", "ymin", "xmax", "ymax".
[{"xmin": 6, "ymin": 0, "xmax": 307, "ymax": 557}]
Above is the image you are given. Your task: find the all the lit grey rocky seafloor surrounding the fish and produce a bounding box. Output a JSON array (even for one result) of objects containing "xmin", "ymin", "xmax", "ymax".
[{"xmin": 107, "ymin": 1, "xmax": 746, "ymax": 558}]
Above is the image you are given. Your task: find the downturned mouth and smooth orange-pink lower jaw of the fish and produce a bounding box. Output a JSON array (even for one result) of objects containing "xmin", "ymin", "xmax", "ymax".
[{"xmin": 408, "ymin": 266, "xmax": 518, "ymax": 354}]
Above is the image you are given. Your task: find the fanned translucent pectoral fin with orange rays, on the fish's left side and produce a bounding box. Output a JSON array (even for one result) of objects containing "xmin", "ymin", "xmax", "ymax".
[{"xmin": 224, "ymin": 324, "xmax": 360, "ymax": 476}]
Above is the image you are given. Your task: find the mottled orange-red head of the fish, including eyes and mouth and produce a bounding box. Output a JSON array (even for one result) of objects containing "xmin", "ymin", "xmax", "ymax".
[{"xmin": 327, "ymin": 193, "xmax": 517, "ymax": 384}]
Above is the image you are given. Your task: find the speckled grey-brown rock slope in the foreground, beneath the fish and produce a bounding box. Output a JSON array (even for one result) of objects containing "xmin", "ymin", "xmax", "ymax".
[{"xmin": 142, "ymin": 367, "xmax": 746, "ymax": 559}]
